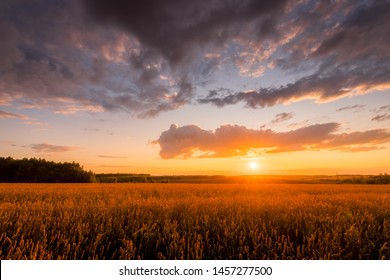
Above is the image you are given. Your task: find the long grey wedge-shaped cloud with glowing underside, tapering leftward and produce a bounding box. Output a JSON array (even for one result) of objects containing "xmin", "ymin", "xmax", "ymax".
[{"xmin": 199, "ymin": 58, "xmax": 390, "ymax": 108}]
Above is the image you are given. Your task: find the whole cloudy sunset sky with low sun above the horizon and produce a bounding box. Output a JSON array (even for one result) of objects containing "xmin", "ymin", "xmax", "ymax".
[{"xmin": 0, "ymin": 0, "xmax": 390, "ymax": 175}]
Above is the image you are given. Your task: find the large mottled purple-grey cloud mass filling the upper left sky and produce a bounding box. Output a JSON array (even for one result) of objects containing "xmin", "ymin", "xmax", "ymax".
[{"xmin": 0, "ymin": 0, "xmax": 198, "ymax": 117}]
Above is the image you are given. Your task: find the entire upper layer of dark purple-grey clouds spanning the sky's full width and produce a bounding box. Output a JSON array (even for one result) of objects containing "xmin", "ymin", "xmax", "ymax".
[{"xmin": 0, "ymin": 0, "xmax": 390, "ymax": 118}]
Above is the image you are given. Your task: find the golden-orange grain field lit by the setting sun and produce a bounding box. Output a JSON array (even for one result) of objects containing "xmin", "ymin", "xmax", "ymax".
[{"xmin": 0, "ymin": 183, "xmax": 390, "ymax": 259}]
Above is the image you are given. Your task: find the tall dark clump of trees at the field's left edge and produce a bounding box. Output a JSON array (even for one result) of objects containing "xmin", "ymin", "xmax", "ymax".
[{"xmin": 0, "ymin": 157, "xmax": 96, "ymax": 183}]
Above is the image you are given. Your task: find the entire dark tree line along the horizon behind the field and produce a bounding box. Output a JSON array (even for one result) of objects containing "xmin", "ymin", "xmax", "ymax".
[{"xmin": 0, "ymin": 157, "xmax": 390, "ymax": 184}]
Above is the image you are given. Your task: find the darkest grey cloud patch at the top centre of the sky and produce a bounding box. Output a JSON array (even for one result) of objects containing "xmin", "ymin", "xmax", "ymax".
[{"xmin": 84, "ymin": 0, "xmax": 286, "ymax": 65}]
